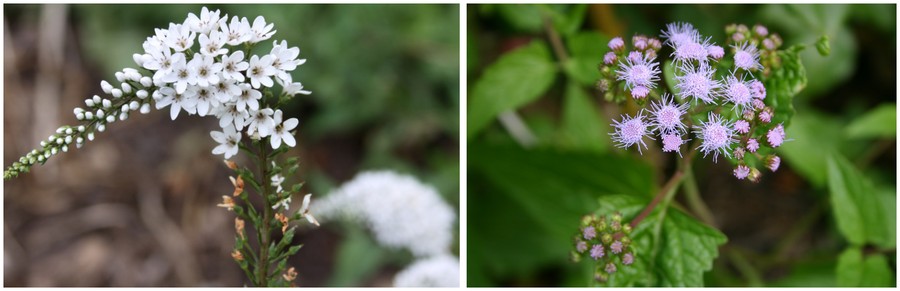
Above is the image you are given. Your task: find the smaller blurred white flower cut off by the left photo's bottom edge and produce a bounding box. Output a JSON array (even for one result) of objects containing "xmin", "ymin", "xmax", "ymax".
[{"xmin": 394, "ymin": 254, "xmax": 459, "ymax": 287}]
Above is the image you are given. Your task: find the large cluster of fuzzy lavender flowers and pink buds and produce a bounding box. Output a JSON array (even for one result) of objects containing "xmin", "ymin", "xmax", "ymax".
[{"xmin": 598, "ymin": 23, "xmax": 785, "ymax": 181}]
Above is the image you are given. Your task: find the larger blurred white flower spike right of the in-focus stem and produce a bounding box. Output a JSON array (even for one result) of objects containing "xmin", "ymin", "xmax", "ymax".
[{"xmin": 313, "ymin": 171, "xmax": 456, "ymax": 257}]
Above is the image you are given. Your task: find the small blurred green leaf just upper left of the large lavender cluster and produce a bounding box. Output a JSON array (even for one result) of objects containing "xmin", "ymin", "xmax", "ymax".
[{"xmin": 565, "ymin": 31, "xmax": 609, "ymax": 87}]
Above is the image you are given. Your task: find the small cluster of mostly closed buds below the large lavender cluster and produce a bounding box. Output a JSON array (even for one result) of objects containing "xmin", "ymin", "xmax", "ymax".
[{"xmin": 572, "ymin": 213, "xmax": 635, "ymax": 282}]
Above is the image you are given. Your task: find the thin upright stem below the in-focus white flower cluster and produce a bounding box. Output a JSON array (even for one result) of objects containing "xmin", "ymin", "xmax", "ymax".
[{"xmin": 256, "ymin": 140, "xmax": 273, "ymax": 287}]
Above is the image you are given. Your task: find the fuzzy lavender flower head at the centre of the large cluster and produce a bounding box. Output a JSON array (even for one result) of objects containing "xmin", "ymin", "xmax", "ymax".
[{"xmin": 675, "ymin": 63, "xmax": 722, "ymax": 103}]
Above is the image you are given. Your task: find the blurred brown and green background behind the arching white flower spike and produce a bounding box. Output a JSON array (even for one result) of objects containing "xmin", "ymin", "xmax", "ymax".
[{"xmin": 3, "ymin": 5, "xmax": 460, "ymax": 286}]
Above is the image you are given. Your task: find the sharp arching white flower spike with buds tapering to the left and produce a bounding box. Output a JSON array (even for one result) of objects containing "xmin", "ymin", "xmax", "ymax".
[{"xmin": 4, "ymin": 7, "xmax": 311, "ymax": 178}]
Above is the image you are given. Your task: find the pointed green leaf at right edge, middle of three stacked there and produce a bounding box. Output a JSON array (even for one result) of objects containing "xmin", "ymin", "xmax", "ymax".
[{"xmin": 828, "ymin": 154, "xmax": 896, "ymax": 248}]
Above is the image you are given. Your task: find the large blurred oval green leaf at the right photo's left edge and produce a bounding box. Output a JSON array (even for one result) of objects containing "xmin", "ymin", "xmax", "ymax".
[{"xmin": 468, "ymin": 41, "xmax": 556, "ymax": 140}]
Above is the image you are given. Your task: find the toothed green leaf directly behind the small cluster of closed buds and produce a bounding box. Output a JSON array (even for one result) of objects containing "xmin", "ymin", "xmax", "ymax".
[{"xmin": 597, "ymin": 195, "xmax": 728, "ymax": 287}]
